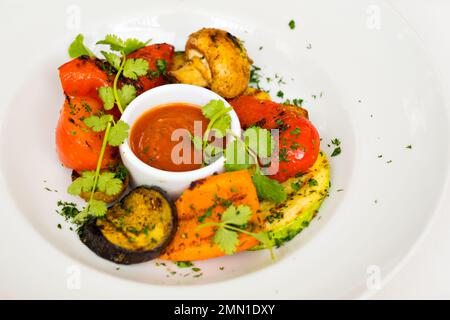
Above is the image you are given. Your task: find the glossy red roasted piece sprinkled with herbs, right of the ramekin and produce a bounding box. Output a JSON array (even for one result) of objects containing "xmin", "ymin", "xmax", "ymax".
[{"xmin": 230, "ymin": 96, "xmax": 320, "ymax": 182}]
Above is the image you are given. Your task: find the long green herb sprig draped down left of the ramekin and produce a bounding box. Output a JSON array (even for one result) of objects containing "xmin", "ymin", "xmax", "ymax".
[{"xmin": 68, "ymin": 34, "xmax": 150, "ymax": 222}]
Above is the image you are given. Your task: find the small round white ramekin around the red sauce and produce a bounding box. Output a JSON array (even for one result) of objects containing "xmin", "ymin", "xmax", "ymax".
[{"xmin": 120, "ymin": 84, "xmax": 241, "ymax": 198}]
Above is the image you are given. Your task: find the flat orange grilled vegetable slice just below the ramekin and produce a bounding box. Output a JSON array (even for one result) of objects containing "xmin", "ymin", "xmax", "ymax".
[{"xmin": 161, "ymin": 170, "xmax": 259, "ymax": 261}]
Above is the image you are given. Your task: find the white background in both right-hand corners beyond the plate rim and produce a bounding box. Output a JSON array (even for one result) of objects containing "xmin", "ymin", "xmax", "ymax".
[{"xmin": 373, "ymin": 0, "xmax": 450, "ymax": 299}]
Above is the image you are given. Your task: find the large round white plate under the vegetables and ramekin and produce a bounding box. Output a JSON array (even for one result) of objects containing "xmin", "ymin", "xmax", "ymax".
[{"xmin": 0, "ymin": 0, "xmax": 449, "ymax": 299}]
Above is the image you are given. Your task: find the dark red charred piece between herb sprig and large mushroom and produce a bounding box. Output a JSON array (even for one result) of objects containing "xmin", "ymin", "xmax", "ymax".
[{"xmin": 124, "ymin": 43, "xmax": 174, "ymax": 94}]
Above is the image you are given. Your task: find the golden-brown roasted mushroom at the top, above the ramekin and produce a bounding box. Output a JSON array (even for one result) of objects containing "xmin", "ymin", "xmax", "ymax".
[{"xmin": 169, "ymin": 28, "xmax": 252, "ymax": 98}]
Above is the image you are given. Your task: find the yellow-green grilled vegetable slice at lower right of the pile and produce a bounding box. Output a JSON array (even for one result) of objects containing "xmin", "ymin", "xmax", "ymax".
[{"xmin": 253, "ymin": 152, "xmax": 330, "ymax": 249}]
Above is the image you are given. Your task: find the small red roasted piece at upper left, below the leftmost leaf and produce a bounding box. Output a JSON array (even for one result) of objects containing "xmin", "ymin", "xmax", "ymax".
[{"xmin": 59, "ymin": 56, "xmax": 114, "ymax": 97}]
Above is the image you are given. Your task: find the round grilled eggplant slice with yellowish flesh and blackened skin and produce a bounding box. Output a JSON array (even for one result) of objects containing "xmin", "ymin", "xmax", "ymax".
[{"xmin": 80, "ymin": 186, "xmax": 177, "ymax": 264}]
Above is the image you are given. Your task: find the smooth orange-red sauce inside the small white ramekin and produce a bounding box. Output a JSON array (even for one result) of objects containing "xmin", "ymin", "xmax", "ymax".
[{"xmin": 130, "ymin": 103, "xmax": 209, "ymax": 172}]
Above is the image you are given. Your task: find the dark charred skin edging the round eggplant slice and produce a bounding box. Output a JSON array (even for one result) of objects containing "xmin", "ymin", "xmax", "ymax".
[{"xmin": 80, "ymin": 186, "xmax": 178, "ymax": 265}]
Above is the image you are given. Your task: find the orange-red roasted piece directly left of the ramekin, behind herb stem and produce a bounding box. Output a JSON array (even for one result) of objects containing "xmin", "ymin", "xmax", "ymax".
[{"xmin": 56, "ymin": 97, "xmax": 119, "ymax": 172}]
